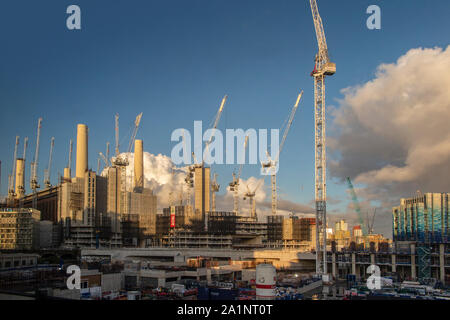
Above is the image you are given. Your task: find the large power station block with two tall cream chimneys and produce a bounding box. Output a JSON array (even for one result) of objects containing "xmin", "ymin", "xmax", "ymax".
[{"xmin": 58, "ymin": 124, "xmax": 156, "ymax": 248}]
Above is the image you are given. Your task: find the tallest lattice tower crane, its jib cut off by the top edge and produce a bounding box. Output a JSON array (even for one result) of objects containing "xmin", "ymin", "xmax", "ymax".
[{"xmin": 309, "ymin": 0, "xmax": 336, "ymax": 275}]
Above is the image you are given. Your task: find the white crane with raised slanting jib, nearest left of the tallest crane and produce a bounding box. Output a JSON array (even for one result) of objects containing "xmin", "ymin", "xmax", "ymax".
[{"xmin": 262, "ymin": 90, "xmax": 303, "ymax": 215}]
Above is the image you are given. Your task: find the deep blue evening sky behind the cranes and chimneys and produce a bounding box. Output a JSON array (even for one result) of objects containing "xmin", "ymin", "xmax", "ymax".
[{"xmin": 0, "ymin": 0, "xmax": 450, "ymax": 236}]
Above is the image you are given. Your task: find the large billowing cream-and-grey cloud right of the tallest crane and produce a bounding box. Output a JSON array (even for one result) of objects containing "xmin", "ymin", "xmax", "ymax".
[{"xmin": 329, "ymin": 46, "xmax": 450, "ymax": 233}]
